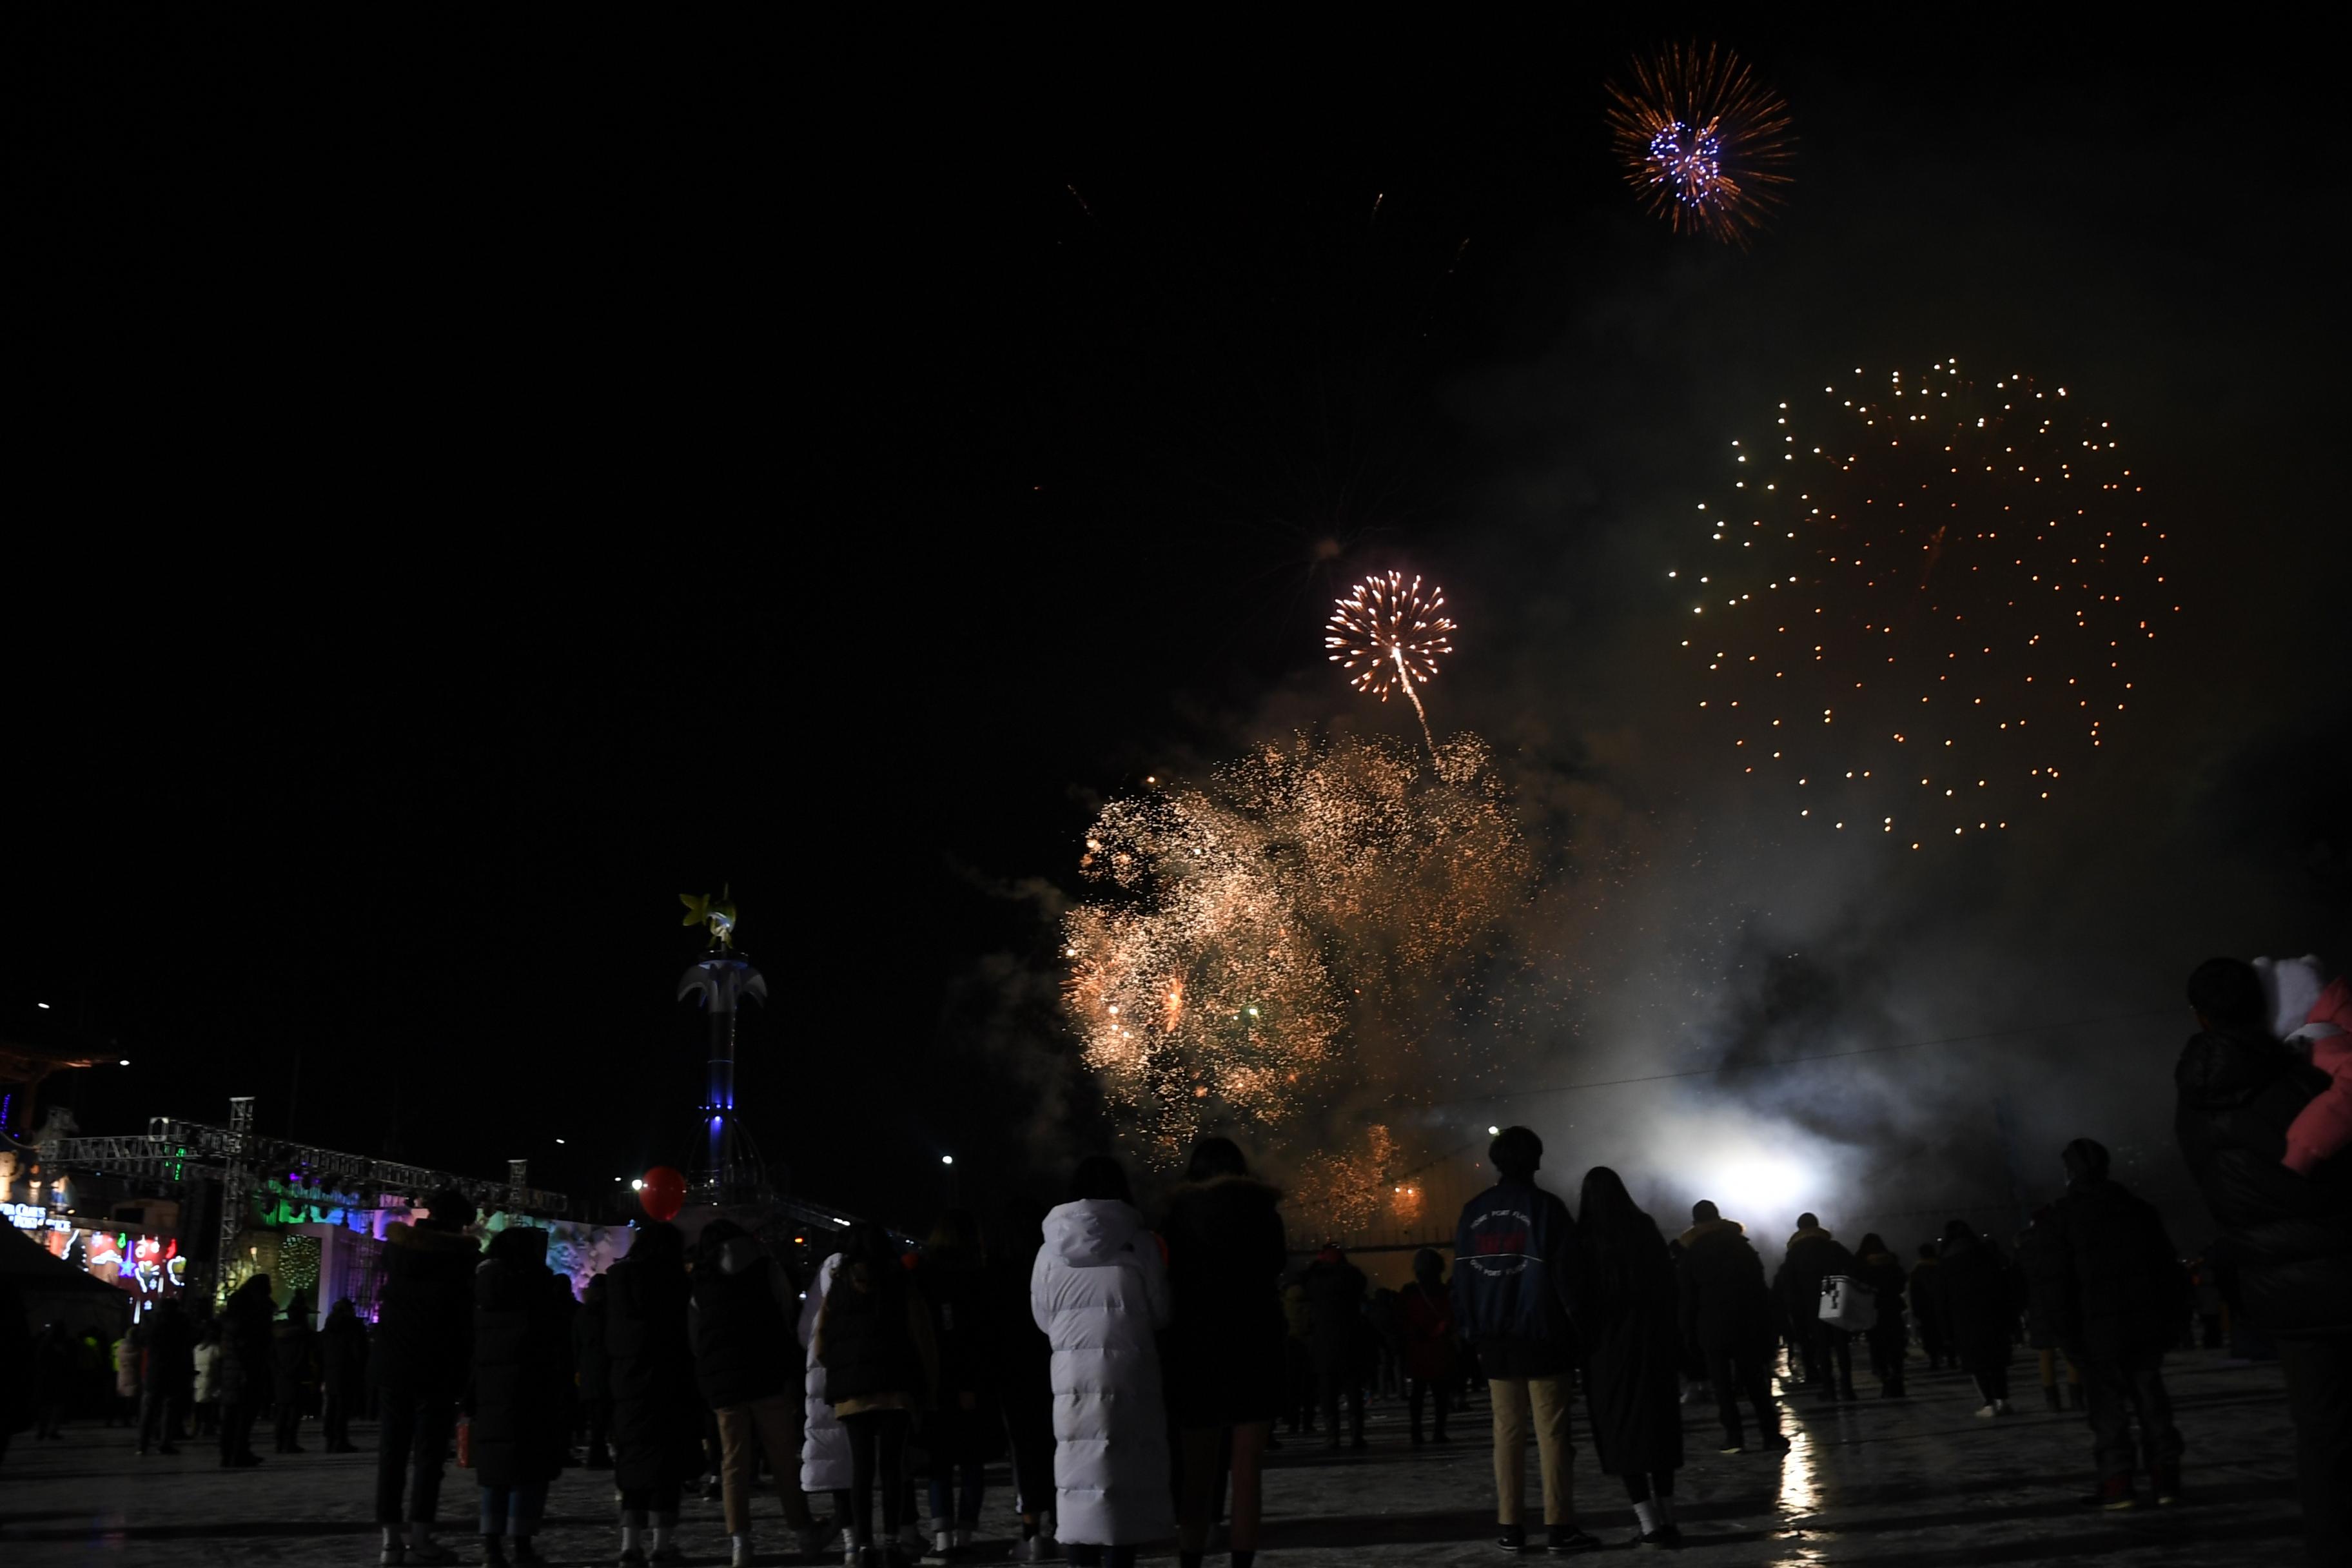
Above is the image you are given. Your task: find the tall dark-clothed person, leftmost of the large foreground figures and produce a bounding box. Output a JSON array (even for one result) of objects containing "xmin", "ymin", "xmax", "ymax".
[{"xmin": 369, "ymin": 1190, "xmax": 482, "ymax": 1565}]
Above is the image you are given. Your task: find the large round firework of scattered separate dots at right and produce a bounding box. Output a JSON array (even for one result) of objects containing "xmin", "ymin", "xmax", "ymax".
[{"xmin": 1667, "ymin": 362, "xmax": 2180, "ymax": 848}]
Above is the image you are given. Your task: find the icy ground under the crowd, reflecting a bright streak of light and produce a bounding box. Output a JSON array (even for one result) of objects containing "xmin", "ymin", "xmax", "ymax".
[{"xmin": 0, "ymin": 1352, "xmax": 2300, "ymax": 1568}]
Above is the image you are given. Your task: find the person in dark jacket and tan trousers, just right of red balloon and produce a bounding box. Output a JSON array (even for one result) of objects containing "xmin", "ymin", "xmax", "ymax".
[{"xmin": 689, "ymin": 1218, "xmax": 816, "ymax": 1568}]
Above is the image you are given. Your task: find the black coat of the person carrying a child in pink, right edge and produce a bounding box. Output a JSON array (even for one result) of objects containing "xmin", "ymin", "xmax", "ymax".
[{"xmin": 2173, "ymin": 1030, "xmax": 2352, "ymax": 1338}]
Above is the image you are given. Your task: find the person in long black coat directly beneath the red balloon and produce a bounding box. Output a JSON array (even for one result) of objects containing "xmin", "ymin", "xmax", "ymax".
[{"xmin": 605, "ymin": 1220, "xmax": 703, "ymax": 1565}]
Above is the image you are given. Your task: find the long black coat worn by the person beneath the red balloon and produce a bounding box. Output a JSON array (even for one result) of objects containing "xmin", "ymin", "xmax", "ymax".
[{"xmin": 605, "ymin": 1230, "xmax": 703, "ymax": 1488}]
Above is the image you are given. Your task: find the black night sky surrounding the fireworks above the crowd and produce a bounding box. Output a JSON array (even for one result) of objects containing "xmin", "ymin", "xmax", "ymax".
[{"xmin": 0, "ymin": 10, "xmax": 2352, "ymax": 1222}]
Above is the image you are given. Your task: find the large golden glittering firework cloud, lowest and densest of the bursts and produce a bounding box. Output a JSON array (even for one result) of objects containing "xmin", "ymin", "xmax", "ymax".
[{"xmin": 1063, "ymin": 738, "xmax": 1536, "ymax": 1164}]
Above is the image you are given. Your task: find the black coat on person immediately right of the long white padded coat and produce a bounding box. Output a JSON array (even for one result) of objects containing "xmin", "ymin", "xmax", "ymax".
[{"xmin": 1159, "ymin": 1175, "xmax": 1289, "ymax": 1429}]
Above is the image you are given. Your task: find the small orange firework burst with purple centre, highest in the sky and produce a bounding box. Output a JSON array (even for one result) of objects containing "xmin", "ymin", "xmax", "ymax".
[{"xmin": 1609, "ymin": 44, "xmax": 1790, "ymax": 244}]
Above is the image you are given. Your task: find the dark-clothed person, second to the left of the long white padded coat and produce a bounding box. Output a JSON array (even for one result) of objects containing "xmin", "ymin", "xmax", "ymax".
[{"xmin": 915, "ymin": 1208, "xmax": 1004, "ymax": 1556}]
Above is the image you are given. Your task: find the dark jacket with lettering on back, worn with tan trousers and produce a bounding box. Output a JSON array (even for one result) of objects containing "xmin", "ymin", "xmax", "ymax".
[{"xmin": 1453, "ymin": 1180, "xmax": 1576, "ymax": 1378}]
